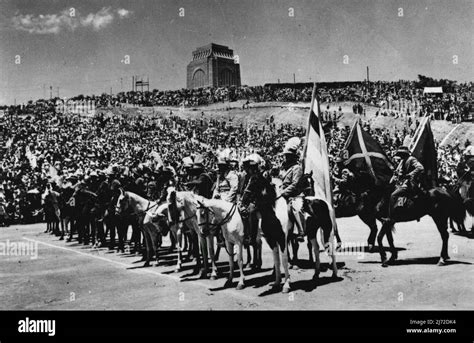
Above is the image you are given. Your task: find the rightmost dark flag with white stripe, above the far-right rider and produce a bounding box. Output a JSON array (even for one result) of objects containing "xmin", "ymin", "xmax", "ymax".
[{"xmin": 409, "ymin": 116, "xmax": 438, "ymax": 187}]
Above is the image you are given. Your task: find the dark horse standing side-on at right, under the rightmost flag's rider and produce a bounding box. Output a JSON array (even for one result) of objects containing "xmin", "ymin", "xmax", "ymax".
[{"xmin": 376, "ymin": 183, "xmax": 464, "ymax": 267}]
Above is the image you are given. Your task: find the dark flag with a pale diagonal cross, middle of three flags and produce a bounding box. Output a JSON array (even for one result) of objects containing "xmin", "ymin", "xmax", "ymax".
[{"xmin": 343, "ymin": 118, "xmax": 393, "ymax": 185}]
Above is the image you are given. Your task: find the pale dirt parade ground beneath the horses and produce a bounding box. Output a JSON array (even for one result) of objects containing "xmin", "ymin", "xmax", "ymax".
[{"xmin": 0, "ymin": 217, "xmax": 474, "ymax": 310}]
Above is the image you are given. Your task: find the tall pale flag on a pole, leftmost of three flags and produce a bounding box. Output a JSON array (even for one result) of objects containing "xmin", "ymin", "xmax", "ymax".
[{"xmin": 303, "ymin": 83, "xmax": 337, "ymax": 267}]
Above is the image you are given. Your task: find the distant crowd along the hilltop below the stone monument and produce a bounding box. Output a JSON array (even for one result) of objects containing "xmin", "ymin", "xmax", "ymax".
[{"xmin": 0, "ymin": 81, "xmax": 472, "ymax": 121}]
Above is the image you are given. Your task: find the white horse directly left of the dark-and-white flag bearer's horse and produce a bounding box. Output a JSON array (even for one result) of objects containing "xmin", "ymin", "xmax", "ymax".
[{"xmin": 196, "ymin": 197, "xmax": 245, "ymax": 290}]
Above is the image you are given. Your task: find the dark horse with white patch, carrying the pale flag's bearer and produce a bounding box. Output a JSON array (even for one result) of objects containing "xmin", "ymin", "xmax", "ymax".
[{"xmin": 242, "ymin": 175, "xmax": 292, "ymax": 293}]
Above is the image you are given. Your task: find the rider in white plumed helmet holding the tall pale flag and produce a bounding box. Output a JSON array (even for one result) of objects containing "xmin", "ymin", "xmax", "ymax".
[{"xmin": 280, "ymin": 137, "xmax": 306, "ymax": 242}]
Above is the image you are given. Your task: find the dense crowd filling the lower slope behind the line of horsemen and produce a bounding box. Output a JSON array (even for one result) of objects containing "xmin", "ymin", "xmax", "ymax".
[{"xmin": 0, "ymin": 101, "xmax": 468, "ymax": 226}]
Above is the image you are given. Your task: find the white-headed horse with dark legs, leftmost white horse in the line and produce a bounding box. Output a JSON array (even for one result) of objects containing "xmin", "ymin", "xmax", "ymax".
[{"xmin": 115, "ymin": 188, "xmax": 167, "ymax": 267}]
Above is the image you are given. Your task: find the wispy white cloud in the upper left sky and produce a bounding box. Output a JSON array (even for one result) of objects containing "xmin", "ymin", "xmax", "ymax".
[{"xmin": 12, "ymin": 7, "xmax": 132, "ymax": 34}]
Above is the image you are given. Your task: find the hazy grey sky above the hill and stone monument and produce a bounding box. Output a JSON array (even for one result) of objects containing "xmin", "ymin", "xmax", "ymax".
[{"xmin": 0, "ymin": 0, "xmax": 474, "ymax": 104}]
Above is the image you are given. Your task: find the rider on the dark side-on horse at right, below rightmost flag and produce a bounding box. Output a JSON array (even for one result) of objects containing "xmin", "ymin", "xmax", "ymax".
[{"xmin": 390, "ymin": 146, "xmax": 425, "ymax": 216}]
